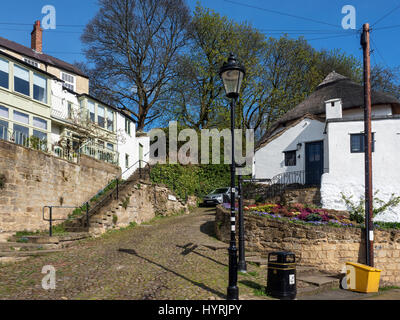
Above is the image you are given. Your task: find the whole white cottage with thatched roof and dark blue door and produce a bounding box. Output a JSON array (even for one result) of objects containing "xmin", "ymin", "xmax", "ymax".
[{"xmin": 253, "ymin": 72, "xmax": 400, "ymax": 222}]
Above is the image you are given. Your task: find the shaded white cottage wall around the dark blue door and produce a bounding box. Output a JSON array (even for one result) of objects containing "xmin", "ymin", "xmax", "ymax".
[{"xmin": 253, "ymin": 118, "xmax": 329, "ymax": 179}]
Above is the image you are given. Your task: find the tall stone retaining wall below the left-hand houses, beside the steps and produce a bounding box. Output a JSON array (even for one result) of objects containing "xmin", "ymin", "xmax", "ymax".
[{"xmin": 0, "ymin": 140, "xmax": 120, "ymax": 238}]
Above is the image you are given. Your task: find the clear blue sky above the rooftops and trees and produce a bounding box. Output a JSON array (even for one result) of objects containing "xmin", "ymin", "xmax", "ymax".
[{"xmin": 0, "ymin": 0, "xmax": 400, "ymax": 67}]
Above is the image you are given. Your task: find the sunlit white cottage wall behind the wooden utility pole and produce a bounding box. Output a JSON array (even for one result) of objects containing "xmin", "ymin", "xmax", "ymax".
[{"xmin": 321, "ymin": 119, "xmax": 400, "ymax": 222}]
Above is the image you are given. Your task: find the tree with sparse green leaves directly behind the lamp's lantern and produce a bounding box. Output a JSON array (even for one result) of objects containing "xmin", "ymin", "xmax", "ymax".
[{"xmin": 164, "ymin": 6, "xmax": 265, "ymax": 129}]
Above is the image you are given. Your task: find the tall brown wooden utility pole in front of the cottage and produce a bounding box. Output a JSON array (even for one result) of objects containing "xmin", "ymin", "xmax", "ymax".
[{"xmin": 361, "ymin": 23, "xmax": 374, "ymax": 267}]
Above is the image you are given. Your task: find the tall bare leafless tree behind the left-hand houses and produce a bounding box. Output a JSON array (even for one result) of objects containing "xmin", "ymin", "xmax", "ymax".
[{"xmin": 82, "ymin": 0, "xmax": 190, "ymax": 130}]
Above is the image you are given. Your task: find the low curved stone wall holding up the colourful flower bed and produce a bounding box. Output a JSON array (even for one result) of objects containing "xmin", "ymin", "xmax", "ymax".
[{"xmin": 215, "ymin": 206, "xmax": 400, "ymax": 286}]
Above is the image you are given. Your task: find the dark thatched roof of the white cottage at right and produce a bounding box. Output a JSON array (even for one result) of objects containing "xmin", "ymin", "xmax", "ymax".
[{"xmin": 256, "ymin": 71, "xmax": 400, "ymax": 148}]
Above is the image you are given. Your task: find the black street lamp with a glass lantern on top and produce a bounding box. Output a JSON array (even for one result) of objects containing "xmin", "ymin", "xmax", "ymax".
[{"xmin": 219, "ymin": 53, "xmax": 246, "ymax": 300}]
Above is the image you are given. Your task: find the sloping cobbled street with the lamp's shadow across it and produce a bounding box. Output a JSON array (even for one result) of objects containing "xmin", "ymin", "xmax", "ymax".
[{"xmin": 0, "ymin": 208, "xmax": 266, "ymax": 300}]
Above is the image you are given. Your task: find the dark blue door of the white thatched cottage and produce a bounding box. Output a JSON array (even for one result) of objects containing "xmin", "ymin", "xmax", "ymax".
[{"xmin": 305, "ymin": 141, "xmax": 324, "ymax": 186}]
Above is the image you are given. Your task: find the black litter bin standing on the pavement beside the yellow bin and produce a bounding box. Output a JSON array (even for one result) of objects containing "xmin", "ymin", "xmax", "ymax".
[{"xmin": 266, "ymin": 252, "xmax": 297, "ymax": 300}]
